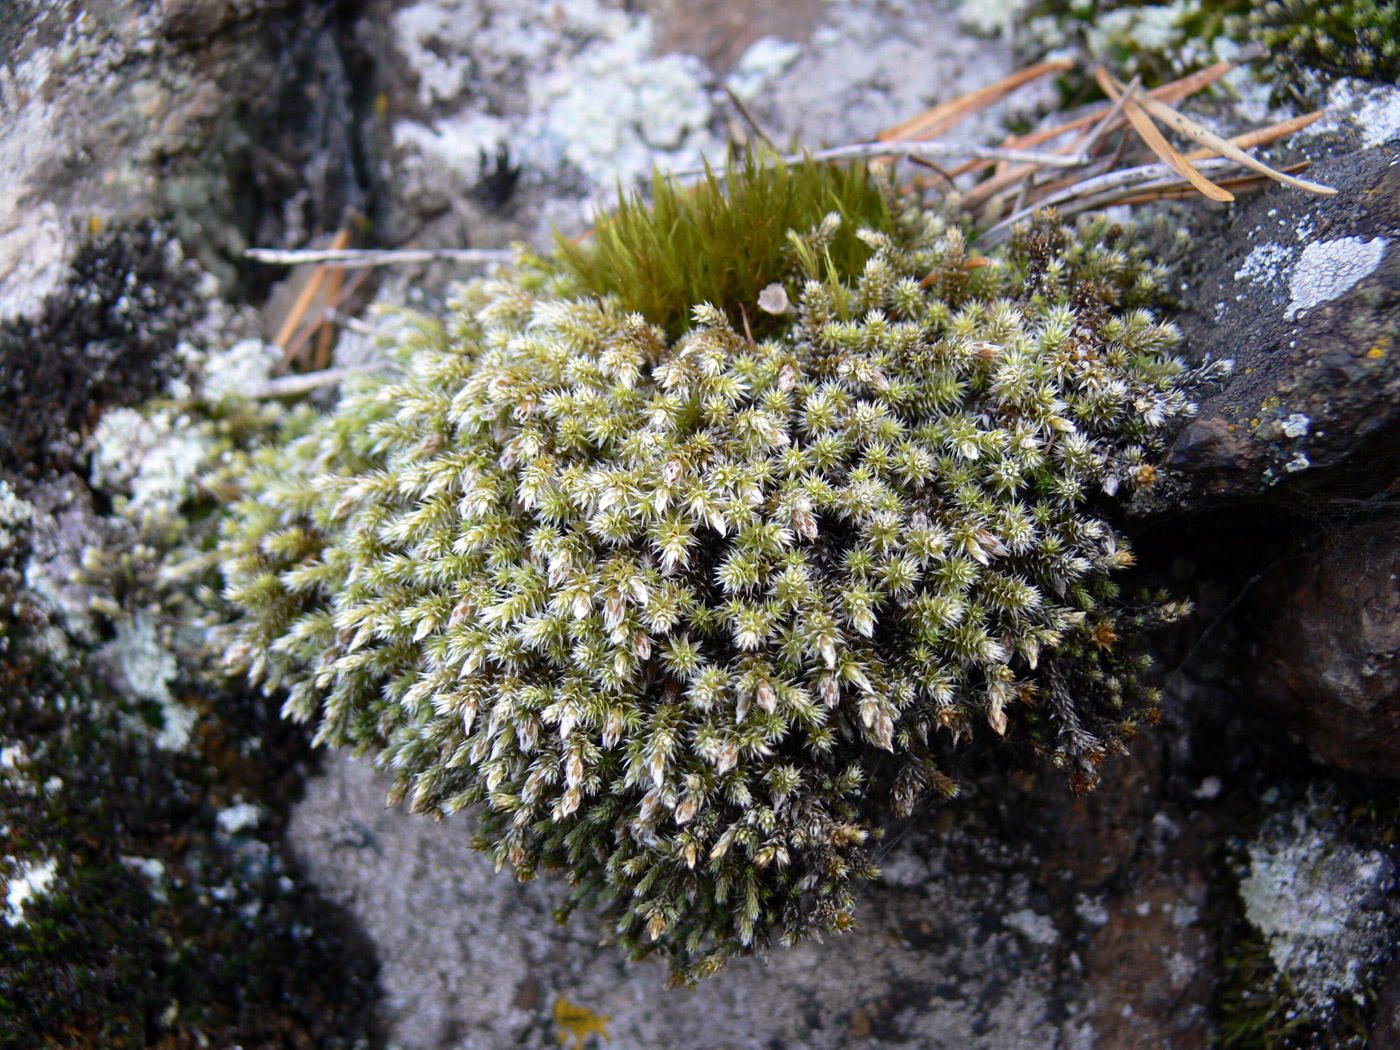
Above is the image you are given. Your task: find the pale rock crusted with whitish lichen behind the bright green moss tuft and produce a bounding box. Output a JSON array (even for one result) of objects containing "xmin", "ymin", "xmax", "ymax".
[{"xmin": 368, "ymin": 0, "xmax": 1050, "ymax": 253}]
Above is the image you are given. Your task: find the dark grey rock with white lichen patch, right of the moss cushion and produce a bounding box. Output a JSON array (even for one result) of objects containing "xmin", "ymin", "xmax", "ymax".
[{"xmin": 1158, "ymin": 147, "xmax": 1400, "ymax": 510}]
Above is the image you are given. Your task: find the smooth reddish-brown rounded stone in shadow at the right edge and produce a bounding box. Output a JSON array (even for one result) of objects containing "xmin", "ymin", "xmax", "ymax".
[{"xmin": 1250, "ymin": 521, "xmax": 1400, "ymax": 776}]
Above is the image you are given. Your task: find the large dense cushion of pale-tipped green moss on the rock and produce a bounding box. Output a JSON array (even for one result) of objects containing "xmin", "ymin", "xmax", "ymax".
[{"xmin": 218, "ymin": 168, "xmax": 1191, "ymax": 976}]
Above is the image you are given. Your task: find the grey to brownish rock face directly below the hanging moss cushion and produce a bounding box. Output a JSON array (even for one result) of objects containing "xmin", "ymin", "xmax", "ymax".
[{"xmin": 290, "ymin": 756, "xmax": 1075, "ymax": 1050}]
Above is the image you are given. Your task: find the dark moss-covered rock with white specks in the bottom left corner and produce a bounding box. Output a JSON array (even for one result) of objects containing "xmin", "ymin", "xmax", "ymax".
[{"xmin": 0, "ymin": 543, "xmax": 382, "ymax": 1050}]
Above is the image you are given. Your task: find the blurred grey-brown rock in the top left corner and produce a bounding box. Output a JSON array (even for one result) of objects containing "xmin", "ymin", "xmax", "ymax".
[{"xmin": 0, "ymin": 0, "xmax": 365, "ymax": 319}]
